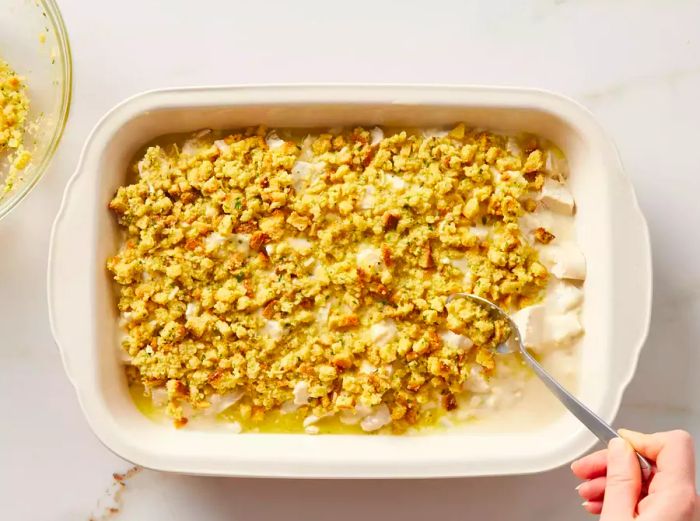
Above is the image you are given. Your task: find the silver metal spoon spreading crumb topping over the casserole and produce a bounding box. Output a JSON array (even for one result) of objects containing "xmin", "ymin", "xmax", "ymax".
[{"xmin": 447, "ymin": 293, "xmax": 652, "ymax": 481}]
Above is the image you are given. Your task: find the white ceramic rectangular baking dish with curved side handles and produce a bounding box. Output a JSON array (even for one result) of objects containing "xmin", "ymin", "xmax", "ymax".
[{"xmin": 48, "ymin": 85, "xmax": 652, "ymax": 477}]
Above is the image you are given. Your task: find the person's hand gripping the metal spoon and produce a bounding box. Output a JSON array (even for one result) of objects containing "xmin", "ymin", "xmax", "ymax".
[{"xmin": 571, "ymin": 429, "xmax": 700, "ymax": 521}]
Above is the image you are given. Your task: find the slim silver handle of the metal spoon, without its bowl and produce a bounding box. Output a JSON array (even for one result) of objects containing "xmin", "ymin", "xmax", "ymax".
[{"xmin": 520, "ymin": 348, "xmax": 652, "ymax": 480}]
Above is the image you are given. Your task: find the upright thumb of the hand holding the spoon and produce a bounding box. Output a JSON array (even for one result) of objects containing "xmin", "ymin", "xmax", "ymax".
[{"xmin": 600, "ymin": 438, "xmax": 642, "ymax": 521}]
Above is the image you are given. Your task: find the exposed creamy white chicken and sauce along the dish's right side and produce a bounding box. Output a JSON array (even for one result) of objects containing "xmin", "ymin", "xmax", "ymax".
[{"xmin": 445, "ymin": 170, "xmax": 586, "ymax": 432}]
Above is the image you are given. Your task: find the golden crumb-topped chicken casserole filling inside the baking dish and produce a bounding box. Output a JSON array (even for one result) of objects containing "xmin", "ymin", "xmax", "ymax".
[{"xmin": 107, "ymin": 124, "xmax": 585, "ymax": 433}]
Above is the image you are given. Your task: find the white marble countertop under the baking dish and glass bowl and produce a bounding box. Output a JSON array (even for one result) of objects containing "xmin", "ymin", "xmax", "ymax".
[{"xmin": 0, "ymin": 0, "xmax": 700, "ymax": 521}]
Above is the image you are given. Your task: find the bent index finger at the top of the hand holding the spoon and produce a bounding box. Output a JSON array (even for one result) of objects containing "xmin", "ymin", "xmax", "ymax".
[{"xmin": 620, "ymin": 429, "xmax": 695, "ymax": 487}]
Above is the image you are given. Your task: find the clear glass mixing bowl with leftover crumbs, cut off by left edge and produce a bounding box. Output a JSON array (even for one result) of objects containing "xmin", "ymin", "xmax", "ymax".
[{"xmin": 0, "ymin": 0, "xmax": 72, "ymax": 219}]
